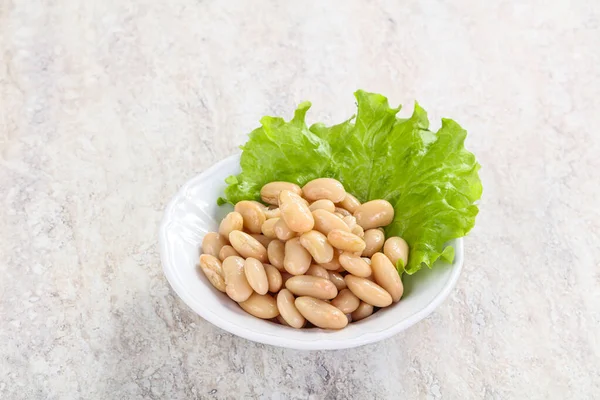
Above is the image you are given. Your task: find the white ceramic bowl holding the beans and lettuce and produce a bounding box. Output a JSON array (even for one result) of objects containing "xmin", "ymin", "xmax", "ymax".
[{"xmin": 159, "ymin": 154, "xmax": 463, "ymax": 350}]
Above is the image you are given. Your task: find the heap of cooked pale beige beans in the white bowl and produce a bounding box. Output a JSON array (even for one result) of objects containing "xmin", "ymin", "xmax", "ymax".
[{"xmin": 200, "ymin": 178, "xmax": 408, "ymax": 329}]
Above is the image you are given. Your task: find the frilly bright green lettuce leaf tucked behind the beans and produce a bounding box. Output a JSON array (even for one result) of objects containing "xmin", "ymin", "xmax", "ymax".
[{"xmin": 221, "ymin": 90, "xmax": 482, "ymax": 274}]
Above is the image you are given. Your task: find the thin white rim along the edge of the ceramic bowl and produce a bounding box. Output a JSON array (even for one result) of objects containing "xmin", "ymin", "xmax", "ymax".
[{"xmin": 158, "ymin": 153, "xmax": 464, "ymax": 350}]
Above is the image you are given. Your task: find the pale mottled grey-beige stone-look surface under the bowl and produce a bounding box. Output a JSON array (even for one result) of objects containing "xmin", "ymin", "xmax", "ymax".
[{"xmin": 0, "ymin": 0, "xmax": 600, "ymax": 400}]
